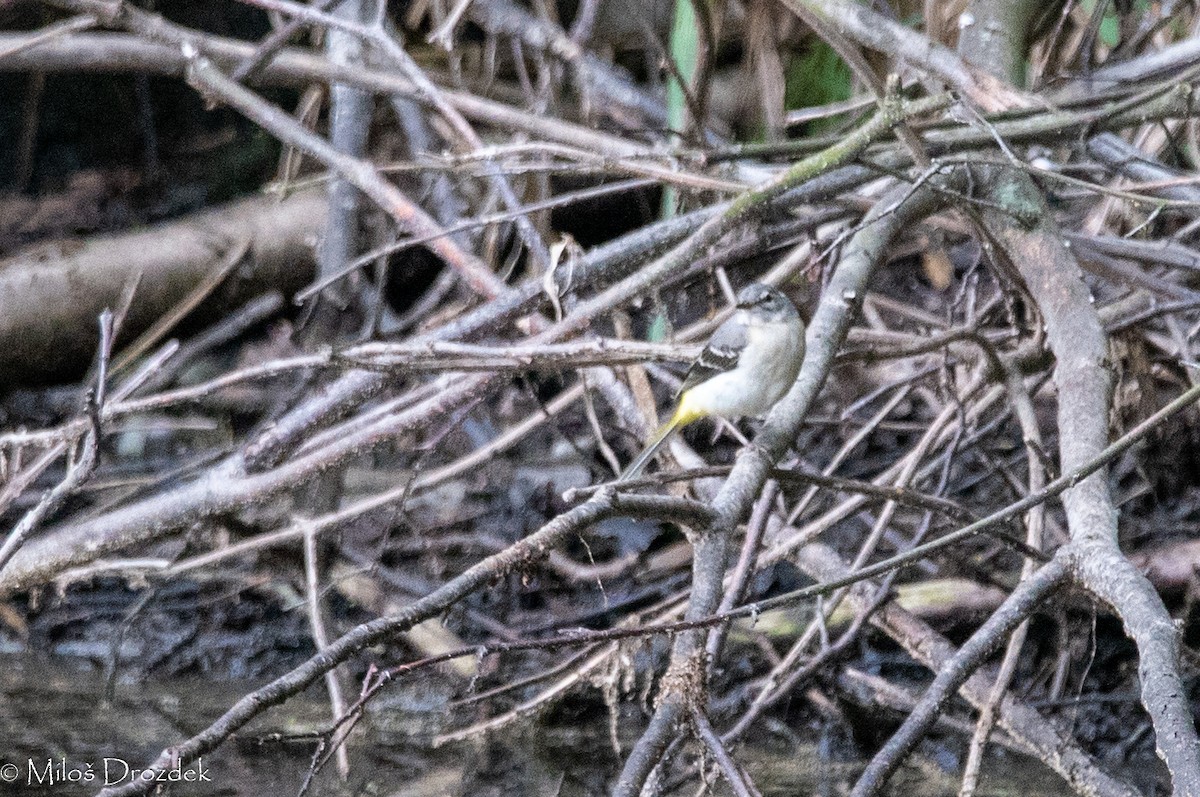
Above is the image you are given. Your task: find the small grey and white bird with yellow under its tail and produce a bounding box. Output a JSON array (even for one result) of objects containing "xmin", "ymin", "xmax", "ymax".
[{"xmin": 617, "ymin": 282, "xmax": 804, "ymax": 483}]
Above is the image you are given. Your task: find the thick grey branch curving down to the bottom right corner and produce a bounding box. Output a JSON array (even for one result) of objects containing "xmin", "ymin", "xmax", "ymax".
[{"xmin": 983, "ymin": 169, "xmax": 1200, "ymax": 796}]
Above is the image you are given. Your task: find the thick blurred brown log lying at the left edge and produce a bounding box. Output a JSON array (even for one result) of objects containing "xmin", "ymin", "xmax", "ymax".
[{"xmin": 0, "ymin": 191, "xmax": 325, "ymax": 384}]
